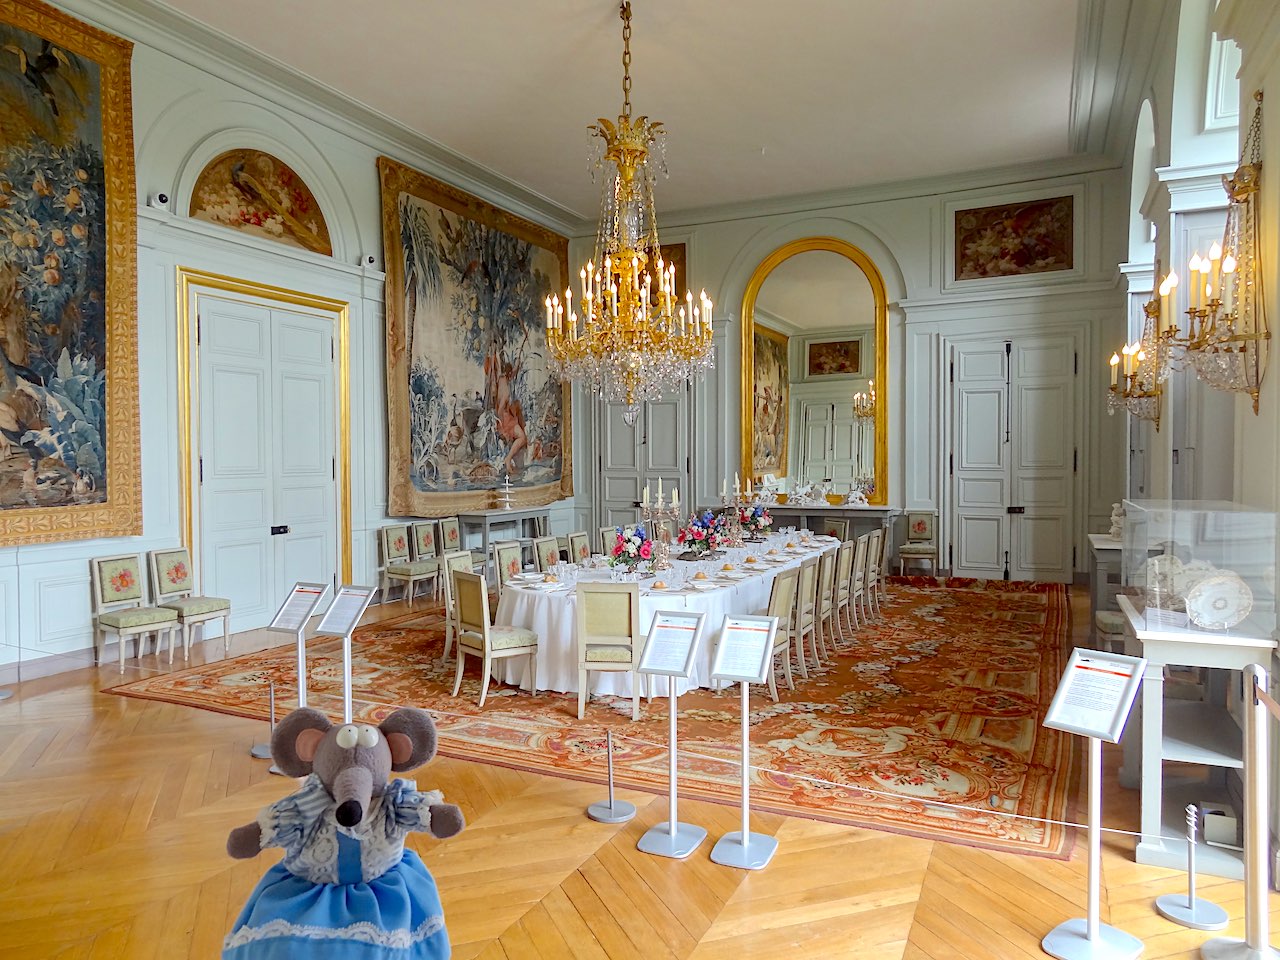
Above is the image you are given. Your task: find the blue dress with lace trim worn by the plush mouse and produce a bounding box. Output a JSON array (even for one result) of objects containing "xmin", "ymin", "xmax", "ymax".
[{"xmin": 223, "ymin": 773, "xmax": 451, "ymax": 960}]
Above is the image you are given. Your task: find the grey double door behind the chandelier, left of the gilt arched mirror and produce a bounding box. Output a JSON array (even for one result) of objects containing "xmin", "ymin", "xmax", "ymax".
[{"xmin": 595, "ymin": 388, "xmax": 694, "ymax": 526}]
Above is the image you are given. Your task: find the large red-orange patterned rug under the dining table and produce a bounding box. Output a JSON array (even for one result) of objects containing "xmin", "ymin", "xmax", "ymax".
[{"xmin": 108, "ymin": 577, "xmax": 1078, "ymax": 859}]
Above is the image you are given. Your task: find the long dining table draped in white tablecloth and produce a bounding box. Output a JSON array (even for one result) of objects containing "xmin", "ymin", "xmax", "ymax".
[{"xmin": 493, "ymin": 534, "xmax": 840, "ymax": 696}]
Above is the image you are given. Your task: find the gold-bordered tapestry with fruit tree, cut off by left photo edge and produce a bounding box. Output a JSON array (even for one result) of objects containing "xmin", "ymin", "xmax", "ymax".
[{"xmin": 0, "ymin": 0, "xmax": 142, "ymax": 545}]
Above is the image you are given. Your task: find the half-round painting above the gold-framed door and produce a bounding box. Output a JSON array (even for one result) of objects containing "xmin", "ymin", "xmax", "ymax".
[{"xmin": 189, "ymin": 150, "xmax": 333, "ymax": 256}]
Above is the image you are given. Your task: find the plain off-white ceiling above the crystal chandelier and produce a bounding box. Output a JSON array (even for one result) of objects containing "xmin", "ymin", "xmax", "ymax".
[{"xmin": 147, "ymin": 0, "xmax": 1100, "ymax": 220}]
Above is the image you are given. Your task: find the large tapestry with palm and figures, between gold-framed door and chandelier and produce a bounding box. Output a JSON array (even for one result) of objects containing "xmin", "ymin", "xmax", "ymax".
[{"xmin": 378, "ymin": 157, "xmax": 573, "ymax": 517}]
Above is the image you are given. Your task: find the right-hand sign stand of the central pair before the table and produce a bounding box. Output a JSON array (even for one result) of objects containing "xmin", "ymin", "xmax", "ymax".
[{"xmin": 712, "ymin": 616, "xmax": 778, "ymax": 870}]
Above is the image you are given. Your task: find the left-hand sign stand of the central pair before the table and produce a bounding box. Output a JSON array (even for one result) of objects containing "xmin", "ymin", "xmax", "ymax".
[{"xmin": 636, "ymin": 611, "xmax": 707, "ymax": 860}]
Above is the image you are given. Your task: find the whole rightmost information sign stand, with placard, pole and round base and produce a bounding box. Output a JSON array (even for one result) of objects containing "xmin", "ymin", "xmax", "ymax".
[{"xmin": 1041, "ymin": 648, "xmax": 1147, "ymax": 960}]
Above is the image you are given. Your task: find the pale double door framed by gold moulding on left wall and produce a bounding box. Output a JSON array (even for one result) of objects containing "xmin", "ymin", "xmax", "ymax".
[{"xmin": 197, "ymin": 298, "xmax": 338, "ymax": 632}]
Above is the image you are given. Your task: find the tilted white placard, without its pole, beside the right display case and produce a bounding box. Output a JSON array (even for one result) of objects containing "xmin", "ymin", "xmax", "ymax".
[{"xmin": 1044, "ymin": 648, "xmax": 1147, "ymax": 744}]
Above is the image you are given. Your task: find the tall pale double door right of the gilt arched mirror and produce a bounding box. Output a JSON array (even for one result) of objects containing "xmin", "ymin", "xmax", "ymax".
[{"xmin": 948, "ymin": 337, "xmax": 1078, "ymax": 582}]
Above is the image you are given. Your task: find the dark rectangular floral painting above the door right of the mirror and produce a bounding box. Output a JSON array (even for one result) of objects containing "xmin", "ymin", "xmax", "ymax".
[{"xmin": 955, "ymin": 196, "xmax": 1075, "ymax": 280}]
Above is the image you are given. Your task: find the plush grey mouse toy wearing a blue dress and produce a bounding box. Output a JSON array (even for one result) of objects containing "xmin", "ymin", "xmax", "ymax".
[{"xmin": 223, "ymin": 707, "xmax": 462, "ymax": 960}]
